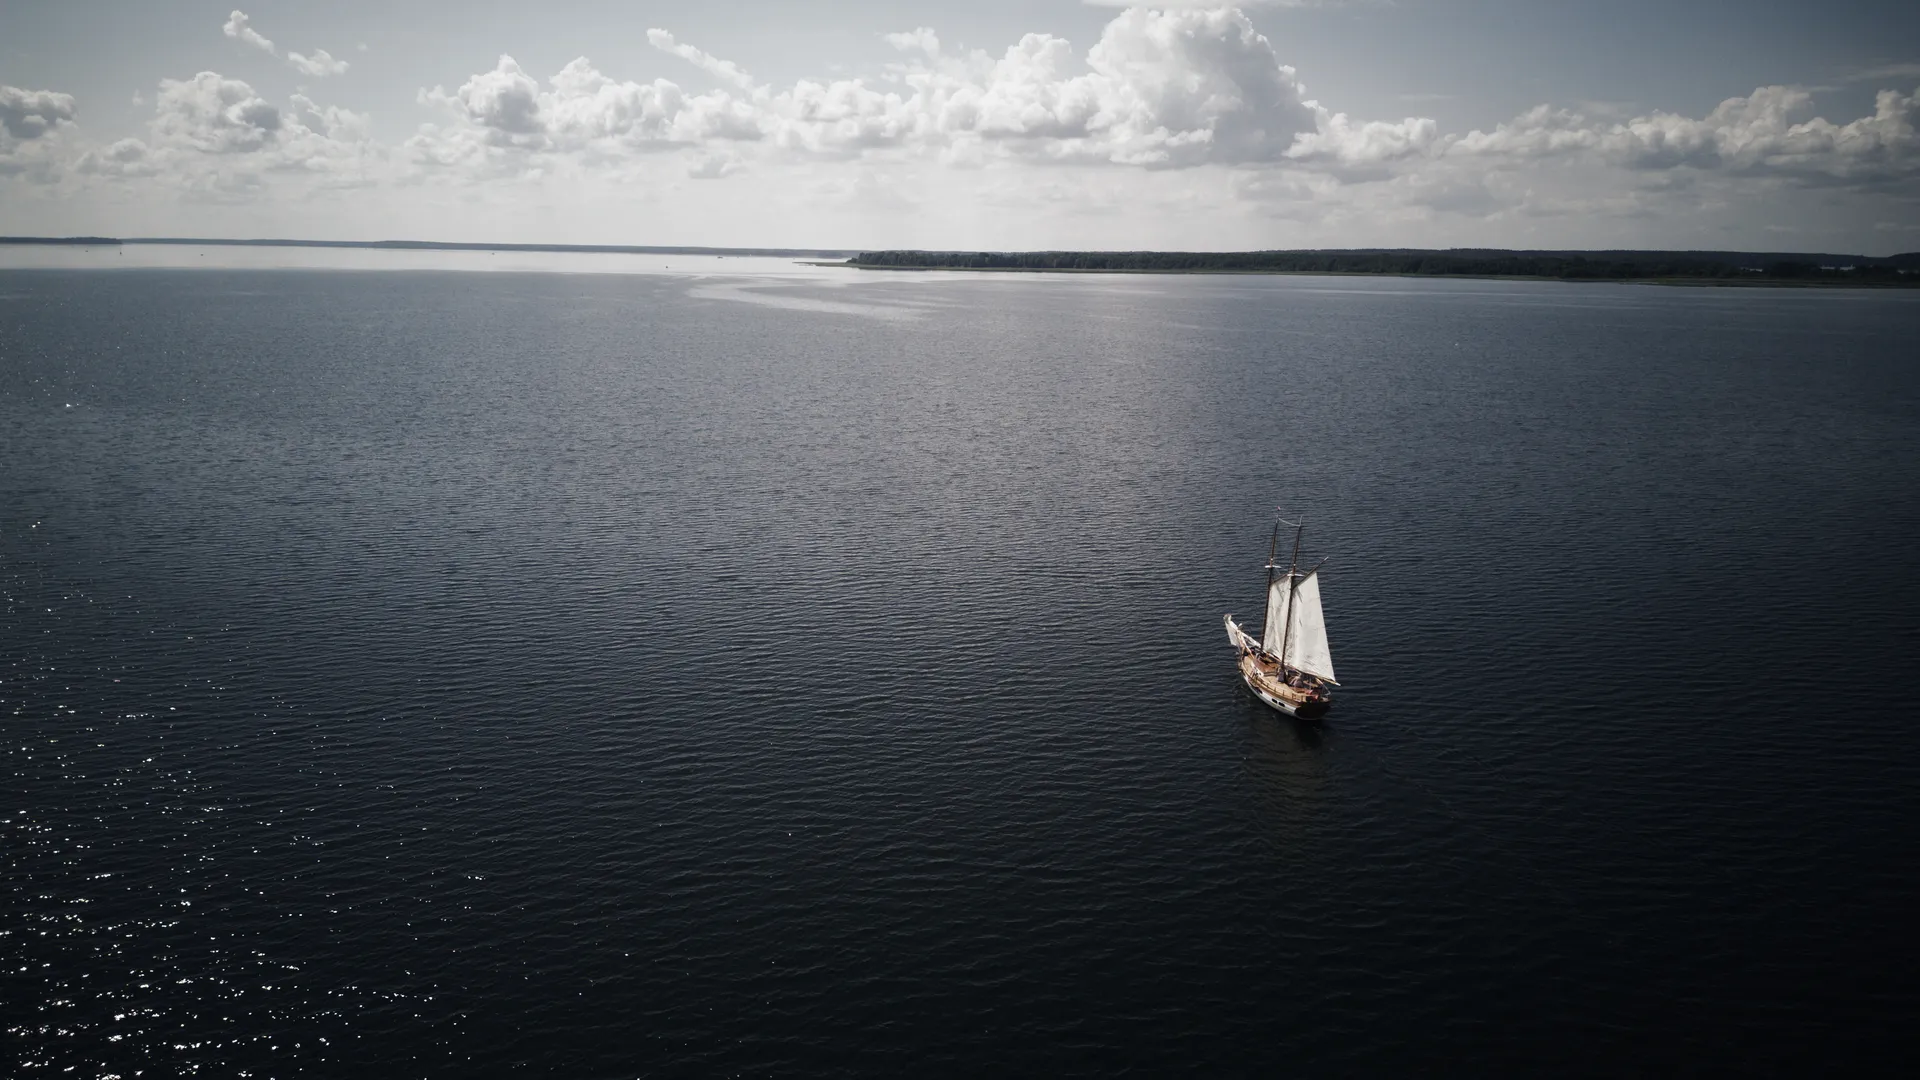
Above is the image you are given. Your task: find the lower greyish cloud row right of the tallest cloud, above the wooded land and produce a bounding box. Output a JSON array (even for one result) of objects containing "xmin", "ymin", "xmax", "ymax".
[{"xmin": 1235, "ymin": 86, "xmax": 1920, "ymax": 235}]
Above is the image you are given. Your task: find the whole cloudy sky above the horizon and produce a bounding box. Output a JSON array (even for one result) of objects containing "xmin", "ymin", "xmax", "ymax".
[{"xmin": 11, "ymin": 0, "xmax": 1920, "ymax": 254}]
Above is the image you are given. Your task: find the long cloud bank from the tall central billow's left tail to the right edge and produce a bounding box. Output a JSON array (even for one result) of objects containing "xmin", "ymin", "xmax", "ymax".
[{"xmin": 397, "ymin": 8, "xmax": 1920, "ymax": 195}]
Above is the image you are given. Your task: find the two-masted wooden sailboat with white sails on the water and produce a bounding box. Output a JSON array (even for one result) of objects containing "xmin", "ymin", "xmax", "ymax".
[{"xmin": 1227, "ymin": 521, "xmax": 1338, "ymax": 721}]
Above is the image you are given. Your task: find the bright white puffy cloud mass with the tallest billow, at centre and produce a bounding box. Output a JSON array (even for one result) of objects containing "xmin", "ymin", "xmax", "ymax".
[{"xmin": 420, "ymin": 10, "xmax": 1336, "ymax": 169}]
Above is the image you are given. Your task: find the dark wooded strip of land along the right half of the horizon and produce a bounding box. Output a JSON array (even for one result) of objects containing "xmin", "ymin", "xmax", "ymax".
[{"xmin": 847, "ymin": 248, "xmax": 1920, "ymax": 286}]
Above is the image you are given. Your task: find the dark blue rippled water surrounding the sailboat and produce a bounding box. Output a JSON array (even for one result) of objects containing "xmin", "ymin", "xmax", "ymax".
[{"xmin": 0, "ymin": 271, "xmax": 1920, "ymax": 1076}]
